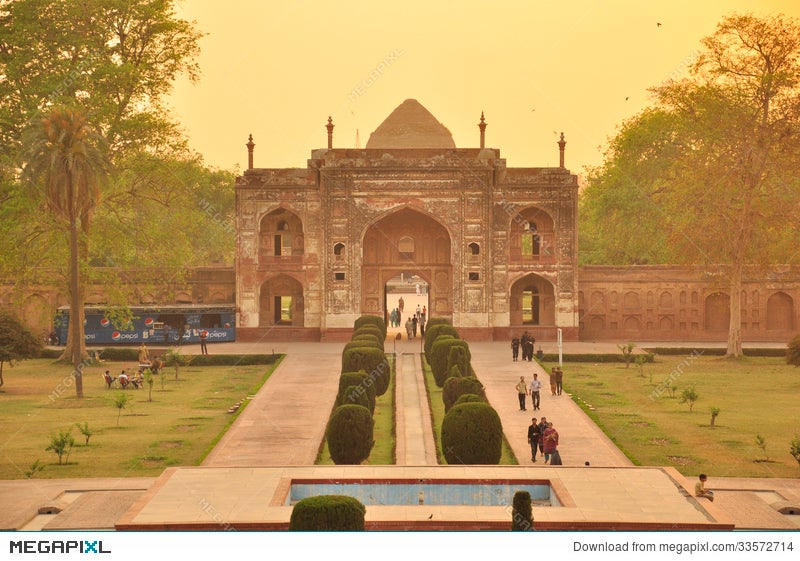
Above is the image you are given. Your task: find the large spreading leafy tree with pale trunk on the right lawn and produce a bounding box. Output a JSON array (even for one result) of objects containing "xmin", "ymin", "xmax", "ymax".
[{"xmin": 579, "ymin": 14, "xmax": 800, "ymax": 357}]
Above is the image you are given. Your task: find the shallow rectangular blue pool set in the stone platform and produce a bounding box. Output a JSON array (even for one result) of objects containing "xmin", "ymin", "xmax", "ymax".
[{"xmin": 286, "ymin": 482, "xmax": 559, "ymax": 506}]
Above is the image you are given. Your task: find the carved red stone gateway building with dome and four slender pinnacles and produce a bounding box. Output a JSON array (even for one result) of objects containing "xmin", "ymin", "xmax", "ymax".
[{"xmin": 236, "ymin": 100, "xmax": 578, "ymax": 340}]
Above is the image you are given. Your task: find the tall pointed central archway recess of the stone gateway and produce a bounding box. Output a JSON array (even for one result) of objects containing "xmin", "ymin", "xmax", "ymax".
[{"xmin": 361, "ymin": 208, "xmax": 453, "ymax": 321}]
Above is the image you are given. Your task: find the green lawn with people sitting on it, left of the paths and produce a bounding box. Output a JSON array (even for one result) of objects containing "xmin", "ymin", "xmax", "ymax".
[{"xmin": 0, "ymin": 359, "xmax": 280, "ymax": 479}]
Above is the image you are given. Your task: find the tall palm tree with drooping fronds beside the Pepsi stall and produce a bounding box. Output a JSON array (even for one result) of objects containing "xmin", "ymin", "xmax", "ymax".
[{"xmin": 24, "ymin": 107, "xmax": 109, "ymax": 397}]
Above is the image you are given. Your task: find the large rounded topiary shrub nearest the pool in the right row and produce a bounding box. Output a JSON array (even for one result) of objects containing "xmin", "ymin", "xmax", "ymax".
[{"xmin": 442, "ymin": 403, "xmax": 503, "ymax": 465}]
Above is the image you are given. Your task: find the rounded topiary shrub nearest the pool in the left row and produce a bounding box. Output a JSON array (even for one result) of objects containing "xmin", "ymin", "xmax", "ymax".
[{"xmin": 325, "ymin": 405, "xmax": 374, "ymax": 465}]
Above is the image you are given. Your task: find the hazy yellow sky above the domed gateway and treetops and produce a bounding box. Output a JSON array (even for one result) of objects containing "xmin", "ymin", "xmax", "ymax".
[{"xmin": 171, "ymin": 0, "xmax": 800, "ymax": 174}]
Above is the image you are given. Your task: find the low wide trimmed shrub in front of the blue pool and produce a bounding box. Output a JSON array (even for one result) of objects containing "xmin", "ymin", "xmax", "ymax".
[{"xmin": 289, "ymin": 495, "xmax": 367, "ymax": 532}]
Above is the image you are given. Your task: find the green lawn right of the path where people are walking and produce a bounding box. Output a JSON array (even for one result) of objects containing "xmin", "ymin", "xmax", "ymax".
[{"xmin": 544, "ymin": 354, "xmax": 800, "ymax": 477}]
